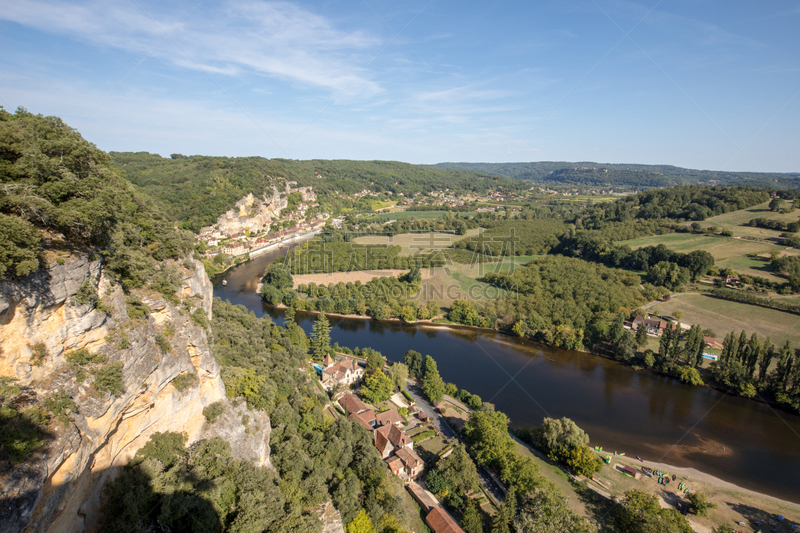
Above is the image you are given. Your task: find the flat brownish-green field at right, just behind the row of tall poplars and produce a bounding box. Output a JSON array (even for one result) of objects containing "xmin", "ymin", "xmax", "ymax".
[{"xmin": 648, "ymin": 294, "xmax": 800, "ymax": 347}]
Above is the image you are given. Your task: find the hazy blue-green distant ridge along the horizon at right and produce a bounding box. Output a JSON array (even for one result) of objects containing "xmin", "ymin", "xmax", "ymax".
[{"xmin": 431, "ymin": 161, "xmax": 800, "ymax": 189}]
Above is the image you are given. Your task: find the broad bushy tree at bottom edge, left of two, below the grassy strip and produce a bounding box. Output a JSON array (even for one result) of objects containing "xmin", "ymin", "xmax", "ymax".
[{"xmin": 514, "ymin": 490, "xmax": 597, "ymax": 533}]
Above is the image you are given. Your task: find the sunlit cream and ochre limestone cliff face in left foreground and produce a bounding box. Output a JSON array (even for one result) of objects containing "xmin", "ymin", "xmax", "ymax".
[{"xmin": 0, "ymin": 256, "xmax": 270, "ymax": 532}]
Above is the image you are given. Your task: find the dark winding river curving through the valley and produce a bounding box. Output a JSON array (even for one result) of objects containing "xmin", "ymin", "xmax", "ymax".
[{"xmin": 214, "ymin": 249, "xmax": 800, "ymax": 503}]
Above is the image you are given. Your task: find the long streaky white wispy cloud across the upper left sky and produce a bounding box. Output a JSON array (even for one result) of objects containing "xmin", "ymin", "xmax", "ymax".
[{"xmin": 0, "ymin": 0, "xmax": 382, "ymax": 96}]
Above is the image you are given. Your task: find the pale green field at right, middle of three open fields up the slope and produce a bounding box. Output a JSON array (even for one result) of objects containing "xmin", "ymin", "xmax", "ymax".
[{"xmin": 618, "ymin": 233, "xmax": 796, "ymax": 282}]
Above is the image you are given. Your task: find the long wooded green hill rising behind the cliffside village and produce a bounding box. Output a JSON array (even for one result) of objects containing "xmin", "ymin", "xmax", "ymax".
[{"xmin": 109, "ymin": 152, "xmax": 529, "ymax": 232}]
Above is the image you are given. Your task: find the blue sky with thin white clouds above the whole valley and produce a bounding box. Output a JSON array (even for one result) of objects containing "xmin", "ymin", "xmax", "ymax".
[{"xmin": 0, "ymin": 0, "xmax": 800, "ymax": 172}]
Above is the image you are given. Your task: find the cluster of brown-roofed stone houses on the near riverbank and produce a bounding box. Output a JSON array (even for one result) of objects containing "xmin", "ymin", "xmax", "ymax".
[{"xmin": 313, "ymin": 355, "xmax": 478, "ymax": 533}]
